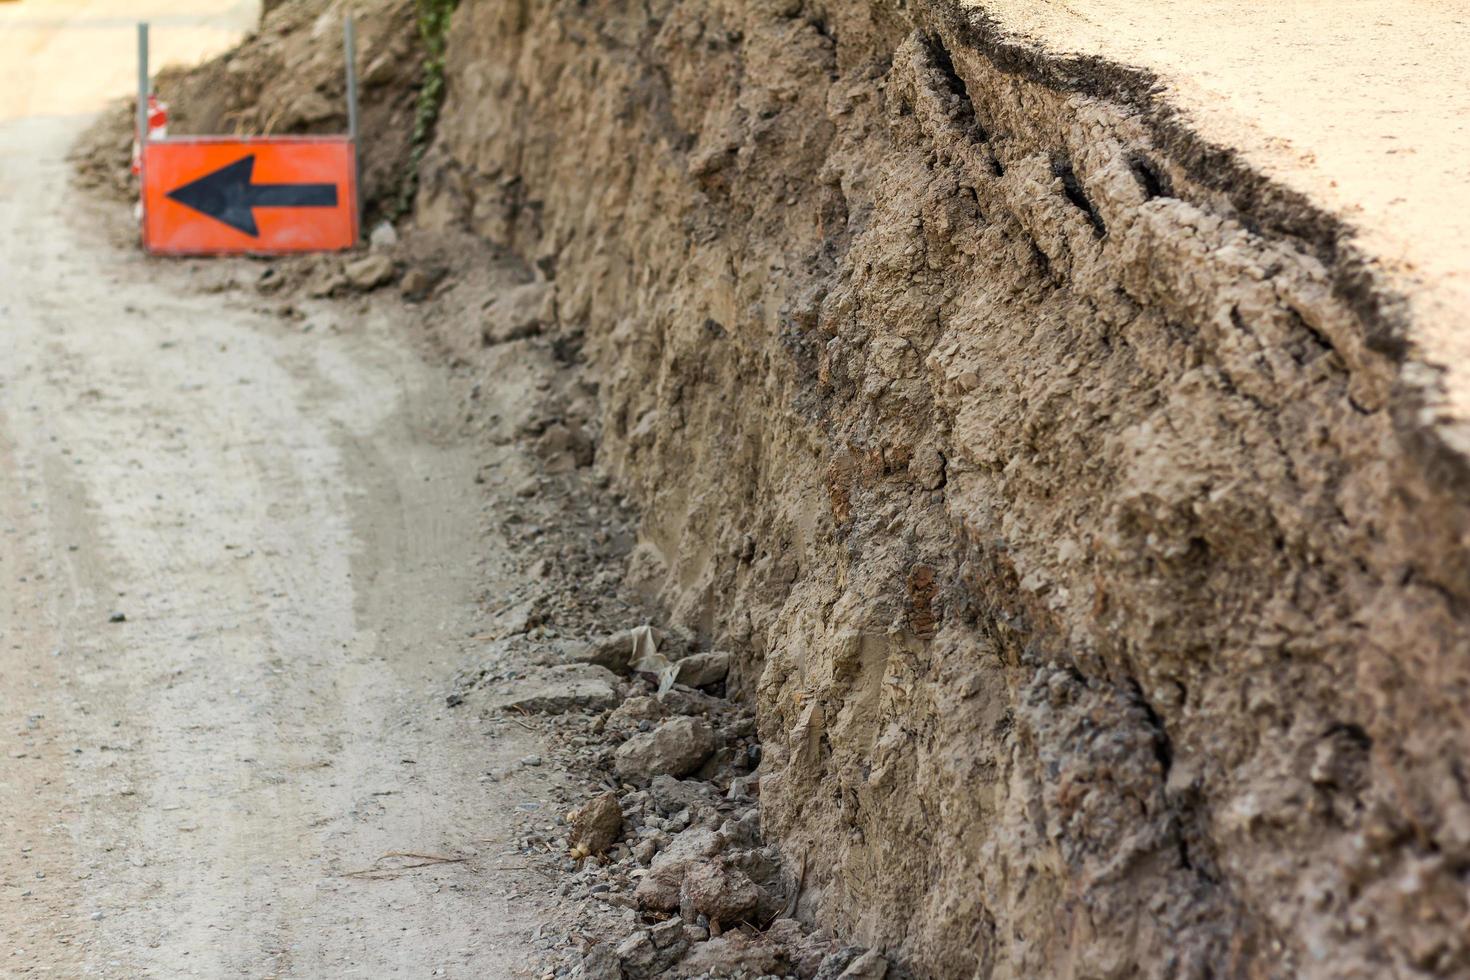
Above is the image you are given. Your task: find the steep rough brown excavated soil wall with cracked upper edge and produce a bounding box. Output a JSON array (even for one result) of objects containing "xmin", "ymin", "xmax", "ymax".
[{"xmin": 419, "ymin": 0, "xmax": 1470, "ymax": 977}]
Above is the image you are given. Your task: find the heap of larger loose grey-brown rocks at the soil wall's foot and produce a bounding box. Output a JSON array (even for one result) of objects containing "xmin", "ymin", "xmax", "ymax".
[{"xmin": 448, "ymin": 626, "xmax": 888, "ymax": 980}]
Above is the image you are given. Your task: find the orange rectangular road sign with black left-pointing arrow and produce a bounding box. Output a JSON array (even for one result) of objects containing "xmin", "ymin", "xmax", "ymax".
[{"xmin": 143, "ymin": 137, "xmax": 357, "ymax": 256}]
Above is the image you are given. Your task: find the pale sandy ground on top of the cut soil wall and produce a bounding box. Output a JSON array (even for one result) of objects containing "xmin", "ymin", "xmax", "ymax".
[{"xmin": 957, "ymin": 0, "xmax": 1470, "ymax": 422}]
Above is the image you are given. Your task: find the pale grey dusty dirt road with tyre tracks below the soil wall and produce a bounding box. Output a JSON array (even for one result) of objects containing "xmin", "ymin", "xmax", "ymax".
[{"xmin": 0, "ymin": 0, "xmax": 545, "ymax": 977}]
